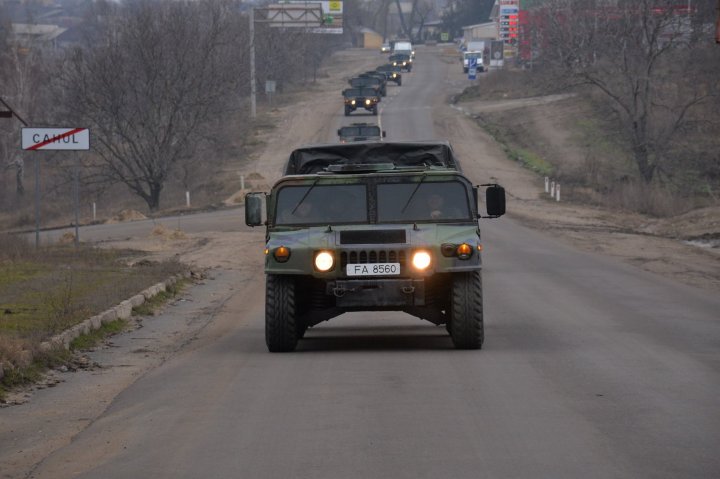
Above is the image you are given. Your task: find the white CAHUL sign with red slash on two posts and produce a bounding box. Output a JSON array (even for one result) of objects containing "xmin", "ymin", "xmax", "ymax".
[{"xmin": 21, "ymin": 128, "xmax": 90, "ymax": 246}]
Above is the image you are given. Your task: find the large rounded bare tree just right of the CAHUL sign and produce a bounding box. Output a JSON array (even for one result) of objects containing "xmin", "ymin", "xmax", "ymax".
[{"xmin": 61, "ymin": 0, "xmax": 248, "ymax": 211}]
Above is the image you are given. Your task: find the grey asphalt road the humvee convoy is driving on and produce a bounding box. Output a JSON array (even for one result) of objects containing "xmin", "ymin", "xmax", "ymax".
[{"xmin": 32, "ymin": 47, "xmax": 720, "ymax": 479}]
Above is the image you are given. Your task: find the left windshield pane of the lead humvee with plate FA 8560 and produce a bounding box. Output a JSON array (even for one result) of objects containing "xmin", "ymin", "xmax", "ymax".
[{"xmin": 275, "ymin": 185, "xmax": 368, "ymax": 225}]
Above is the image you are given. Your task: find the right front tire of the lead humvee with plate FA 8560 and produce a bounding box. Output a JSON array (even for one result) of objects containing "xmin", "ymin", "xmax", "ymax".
[{"xmin": 448, "ymin": 271, "xmax": 485, "ymax": 349}]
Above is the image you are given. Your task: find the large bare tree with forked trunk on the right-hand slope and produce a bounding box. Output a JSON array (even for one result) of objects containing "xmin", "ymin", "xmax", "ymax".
[{"xmin": 537, "ymin": 0, "xmax": 720, "ymax": 183}]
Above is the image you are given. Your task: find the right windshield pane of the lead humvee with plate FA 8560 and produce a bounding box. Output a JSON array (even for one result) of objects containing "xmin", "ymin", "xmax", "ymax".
[{"xmin": 377, "ymin": 181, "xmax": 472, "ymax": 222}]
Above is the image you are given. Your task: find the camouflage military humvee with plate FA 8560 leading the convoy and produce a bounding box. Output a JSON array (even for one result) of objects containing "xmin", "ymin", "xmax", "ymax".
[{"xmin": 245, "ymin": 142, "xmax": 505, "ymax": 352}]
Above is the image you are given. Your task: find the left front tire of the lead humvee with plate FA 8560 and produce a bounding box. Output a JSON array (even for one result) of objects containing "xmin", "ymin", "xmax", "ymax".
[{"xmin": 265, "ymin": 274, "xmax": 298, "ymax": 353}]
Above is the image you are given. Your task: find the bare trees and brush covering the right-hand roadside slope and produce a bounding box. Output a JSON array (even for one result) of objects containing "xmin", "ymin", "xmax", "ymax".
[{"xmin": 525, "ymin": 0, "xmax": 720, "ymax": 199}]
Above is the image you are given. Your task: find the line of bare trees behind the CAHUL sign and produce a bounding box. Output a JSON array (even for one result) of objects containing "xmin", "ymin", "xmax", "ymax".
[{"xmin": 0, "ymin": 0, "xmax": 338, "ymax": 216}]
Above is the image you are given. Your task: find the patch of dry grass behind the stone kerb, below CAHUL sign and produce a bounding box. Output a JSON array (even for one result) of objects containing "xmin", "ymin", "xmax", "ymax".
[{"xmin": 0, "ymin": 232, "xmax": 186, "ymax": 394}]
